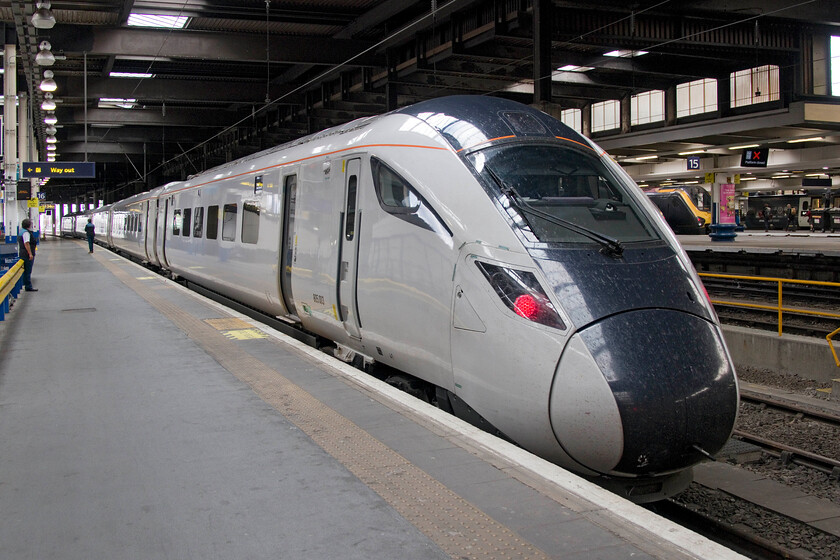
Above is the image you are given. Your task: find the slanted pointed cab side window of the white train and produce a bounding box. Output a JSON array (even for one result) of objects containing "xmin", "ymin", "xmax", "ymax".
[{"xmin": 370, "ymin": 158, "xmax": 452, "ymax": 237}]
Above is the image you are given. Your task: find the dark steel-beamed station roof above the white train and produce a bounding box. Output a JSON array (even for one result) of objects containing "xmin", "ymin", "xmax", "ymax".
[{"xmin": 0, "ymin": 0, "xmax": 840, "ymax": 202}]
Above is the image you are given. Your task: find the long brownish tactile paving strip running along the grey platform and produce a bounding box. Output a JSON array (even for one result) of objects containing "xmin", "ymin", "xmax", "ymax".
[{"xmin": 101, "ymin": 255, "xmax": 548, "ymax": 559}]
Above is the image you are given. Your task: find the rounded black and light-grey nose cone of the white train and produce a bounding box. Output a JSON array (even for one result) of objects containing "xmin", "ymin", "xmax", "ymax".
[{"xmin": 551, "ymin": 309, "xmax": 738, "ymax": 475}]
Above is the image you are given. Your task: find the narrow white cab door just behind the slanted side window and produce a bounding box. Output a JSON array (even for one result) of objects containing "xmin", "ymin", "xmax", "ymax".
[{"xmin": 337, "ymin": 158, "xmax": 361, "ymax": 338}]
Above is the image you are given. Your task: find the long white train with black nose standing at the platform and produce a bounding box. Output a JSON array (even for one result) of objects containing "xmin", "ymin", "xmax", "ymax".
[{"xmin": 90, "ymin": 96, "xmax": 738, "ymax": 502}]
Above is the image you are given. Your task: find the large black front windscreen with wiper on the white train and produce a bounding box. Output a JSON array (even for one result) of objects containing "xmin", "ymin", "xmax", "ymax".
[{"xmin": 467, "ymin": 145, "xmax": 659, "ymax": 243}]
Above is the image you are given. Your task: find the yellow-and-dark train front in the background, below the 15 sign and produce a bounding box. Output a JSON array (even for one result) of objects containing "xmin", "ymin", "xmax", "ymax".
[{"xmin": 645, "ymin": 185, "xmax": 712, "ymax": 235}]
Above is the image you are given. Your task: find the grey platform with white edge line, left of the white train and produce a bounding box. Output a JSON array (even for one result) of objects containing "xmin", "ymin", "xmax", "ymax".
[{"xmin": 0, "ymin": 239, "xmax": 740, "ymax": 560}]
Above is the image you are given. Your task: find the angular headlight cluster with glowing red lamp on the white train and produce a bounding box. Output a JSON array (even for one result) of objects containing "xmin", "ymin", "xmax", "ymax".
[{"xmin": 475, "ymin": 261, "xmax": 566, "ymax": 330}]
